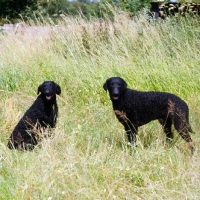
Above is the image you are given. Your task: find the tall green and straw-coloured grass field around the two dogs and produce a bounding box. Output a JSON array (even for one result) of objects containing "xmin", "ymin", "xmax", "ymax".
[{"xmin": 0, "ymin": 10, "xmax": 200, "ymax": 200}]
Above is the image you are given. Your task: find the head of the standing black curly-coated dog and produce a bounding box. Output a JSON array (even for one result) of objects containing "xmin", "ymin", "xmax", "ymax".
[{"xmin": 103, "ymin": 77, "xmax": 127, "ymax": 101}]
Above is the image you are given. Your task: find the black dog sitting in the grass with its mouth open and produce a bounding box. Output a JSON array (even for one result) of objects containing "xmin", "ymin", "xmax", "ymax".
[{"xmin": 8, "ymin": 81, "xmax": 61, "ymax": 150}]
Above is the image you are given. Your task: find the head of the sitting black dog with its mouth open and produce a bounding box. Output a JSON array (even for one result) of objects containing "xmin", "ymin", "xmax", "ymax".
[{"xmin": 37, "ymin": 81, "xmax": 61, "ymax": 101}]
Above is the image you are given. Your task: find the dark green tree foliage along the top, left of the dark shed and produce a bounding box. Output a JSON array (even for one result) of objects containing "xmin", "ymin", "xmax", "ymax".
[{"xmin": 0, "ymin": 0, "xmax": 150, "ymax": 21}]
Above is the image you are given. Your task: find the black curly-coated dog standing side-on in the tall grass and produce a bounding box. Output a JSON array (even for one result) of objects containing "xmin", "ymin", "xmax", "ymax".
[{"xmin": 103, "ymin": 77, "xmax": 193, "ymax": 150}]
